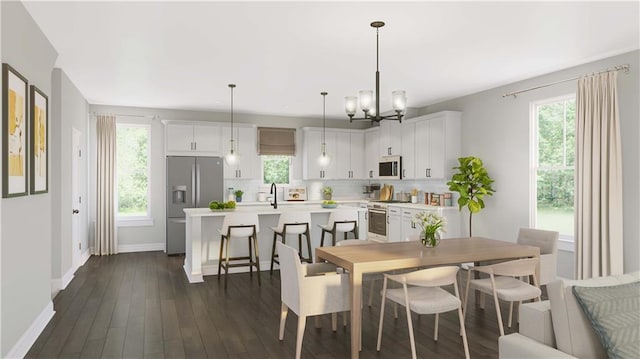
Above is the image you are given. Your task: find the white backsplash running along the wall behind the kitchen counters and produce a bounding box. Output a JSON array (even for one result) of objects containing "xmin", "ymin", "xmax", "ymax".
[{"xmin": 225, "ymin": 180, "xmax": 457, "ymax": 204}]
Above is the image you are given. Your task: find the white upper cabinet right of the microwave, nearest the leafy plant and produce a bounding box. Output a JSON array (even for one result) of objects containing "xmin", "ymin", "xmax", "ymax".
[{"xmin": 403, "ymin": 111, "xmax": 462, "ymax": 179}]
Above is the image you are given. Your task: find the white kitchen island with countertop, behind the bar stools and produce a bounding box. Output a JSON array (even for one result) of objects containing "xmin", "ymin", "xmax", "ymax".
[{"xmin": 184, "ymin": 203, "xmax": 367, "ymax": 283}]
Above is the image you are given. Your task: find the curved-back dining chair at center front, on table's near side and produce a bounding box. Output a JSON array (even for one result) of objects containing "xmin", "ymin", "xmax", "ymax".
[{"xmin": 376, "ymin": 266, "xmax": 469, "ymax": 359}]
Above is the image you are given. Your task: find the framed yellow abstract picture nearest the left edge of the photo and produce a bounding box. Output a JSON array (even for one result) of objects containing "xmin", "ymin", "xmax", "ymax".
[{"xmin": 2, "ymin": 63, "xmax": 29, "ymax": 198}]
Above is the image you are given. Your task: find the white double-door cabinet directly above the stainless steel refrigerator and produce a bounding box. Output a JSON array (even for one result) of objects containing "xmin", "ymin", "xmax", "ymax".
[{"xmin": 165, "ymin": 122, "xmax": 222, "ymax": 156}]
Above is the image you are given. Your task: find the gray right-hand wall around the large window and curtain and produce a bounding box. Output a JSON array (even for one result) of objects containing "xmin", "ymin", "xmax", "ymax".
[{"xmin": 420, "ymin": 51, "xmax": 640, "ymax": 278}]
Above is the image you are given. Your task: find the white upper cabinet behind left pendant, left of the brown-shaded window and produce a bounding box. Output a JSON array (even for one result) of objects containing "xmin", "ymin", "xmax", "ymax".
[{"xmin": 222, "ymin": 126, "xmax": 261, "ymax": 179}]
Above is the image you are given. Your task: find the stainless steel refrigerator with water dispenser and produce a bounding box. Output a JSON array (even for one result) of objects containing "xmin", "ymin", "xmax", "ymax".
[{"xmin": 166, "ymin": 156, "xmax": 224, "ymax": 255}]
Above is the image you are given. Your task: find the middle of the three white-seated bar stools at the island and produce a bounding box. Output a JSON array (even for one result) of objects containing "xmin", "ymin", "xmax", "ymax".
[{"xmin": 269, "ymin": 212, "xmax": 313, "ymax": 274}]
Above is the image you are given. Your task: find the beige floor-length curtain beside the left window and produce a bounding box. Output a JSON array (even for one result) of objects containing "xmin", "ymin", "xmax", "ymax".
[{"xmin": 95, "ymin": 115, "xmax": 118, "ymax": 256}]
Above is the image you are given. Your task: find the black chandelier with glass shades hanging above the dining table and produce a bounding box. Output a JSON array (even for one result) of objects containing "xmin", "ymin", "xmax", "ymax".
[{"xmin": 344, "ymin": 21, "xmax": 407, "ymax": 122}]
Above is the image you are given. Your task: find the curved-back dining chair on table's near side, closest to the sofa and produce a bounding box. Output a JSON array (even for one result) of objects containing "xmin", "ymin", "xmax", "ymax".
[{"xmin": 464, "ymin": 258, "xmax": 542, "ymax": 336}]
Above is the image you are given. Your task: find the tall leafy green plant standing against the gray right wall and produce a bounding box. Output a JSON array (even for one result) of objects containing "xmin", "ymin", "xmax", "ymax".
[{"xmin": 447, "ymin": 156, "xmax": 495, "ymax": 237}]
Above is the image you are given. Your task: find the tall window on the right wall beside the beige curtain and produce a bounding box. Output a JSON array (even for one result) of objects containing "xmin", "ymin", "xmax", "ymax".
[{"xmin": 531, "ymin": 96, "xmax": 576, "ymax": 240}]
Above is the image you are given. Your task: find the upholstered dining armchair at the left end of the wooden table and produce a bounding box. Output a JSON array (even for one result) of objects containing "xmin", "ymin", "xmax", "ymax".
[{"xmin": 276, "ymin": 242, "xmax": 350, "ymax": 359}]
